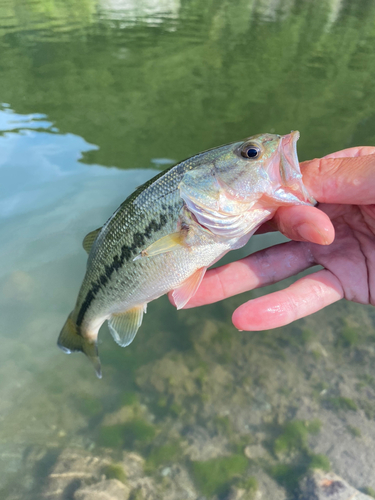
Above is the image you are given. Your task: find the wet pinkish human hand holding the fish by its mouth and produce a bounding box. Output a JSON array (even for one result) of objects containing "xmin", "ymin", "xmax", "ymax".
[{"xmin": 173, "ymin": 147, "xmax": 375, "ymax": 331}]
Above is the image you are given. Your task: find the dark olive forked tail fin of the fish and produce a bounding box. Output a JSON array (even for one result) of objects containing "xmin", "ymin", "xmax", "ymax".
[{"xmin": 57, "ymin": 313, "xmax": 102, "ymax": 378}]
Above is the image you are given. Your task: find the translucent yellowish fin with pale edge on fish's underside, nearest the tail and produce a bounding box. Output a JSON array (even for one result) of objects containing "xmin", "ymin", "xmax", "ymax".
[{"xmin": 108, "ymin": 304, "xmax": 147, "ymax": 347}]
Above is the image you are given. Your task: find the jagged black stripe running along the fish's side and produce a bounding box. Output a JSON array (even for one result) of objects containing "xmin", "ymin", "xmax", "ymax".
[{"xmin": 77, "ymin": 214, "xmax": 168, "ymax": 326}]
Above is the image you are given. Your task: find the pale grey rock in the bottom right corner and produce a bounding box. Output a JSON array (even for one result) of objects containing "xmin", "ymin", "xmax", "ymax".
[{"xmin": 299, "ymin": 470, "xmax": 373, "ymax": 500}]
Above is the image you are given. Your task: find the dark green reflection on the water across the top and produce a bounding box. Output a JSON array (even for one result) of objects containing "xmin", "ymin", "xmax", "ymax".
[{"xmin": 0, "ymin": 0, "xmax": 375, "ymax": 168}]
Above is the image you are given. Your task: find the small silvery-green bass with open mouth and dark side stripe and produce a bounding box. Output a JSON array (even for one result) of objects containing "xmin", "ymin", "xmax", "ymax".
[{"xmin": 58, "ymin": 131, "xmax": 315, "ymax": 378}]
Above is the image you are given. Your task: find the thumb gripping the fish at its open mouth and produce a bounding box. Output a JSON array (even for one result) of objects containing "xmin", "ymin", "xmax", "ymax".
[{"xmin": 301, "ymin": 147, "xmax": 375, "ymax": 205}]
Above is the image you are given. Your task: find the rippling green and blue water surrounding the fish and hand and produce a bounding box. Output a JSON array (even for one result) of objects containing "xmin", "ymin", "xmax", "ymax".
[{"xmin": 0, "ymin": 0, "xmax": 375, "ymax": 500}]
